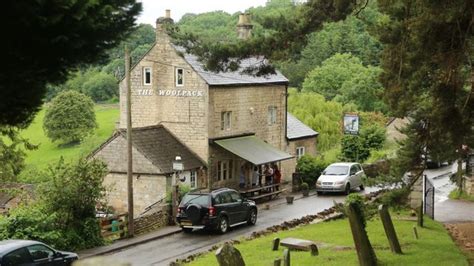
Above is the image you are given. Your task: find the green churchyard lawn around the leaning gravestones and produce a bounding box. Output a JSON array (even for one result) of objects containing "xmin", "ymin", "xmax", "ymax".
[{"xmin": 185, "ymin": 218, "xmax": 468, "ymax": 266}]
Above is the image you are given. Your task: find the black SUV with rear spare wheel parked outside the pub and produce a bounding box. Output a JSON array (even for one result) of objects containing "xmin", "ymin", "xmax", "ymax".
[{"xmin": 176, "ymin": 188, "xmax": 257, "ymax": 233}]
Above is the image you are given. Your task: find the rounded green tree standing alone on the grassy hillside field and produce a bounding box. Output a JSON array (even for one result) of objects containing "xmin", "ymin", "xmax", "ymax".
[{"xmin": 43, "ymin": 91, "xmax": 97, "ymax": 143}]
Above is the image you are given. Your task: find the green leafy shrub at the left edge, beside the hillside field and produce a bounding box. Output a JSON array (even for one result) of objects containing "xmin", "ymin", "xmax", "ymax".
[{"xmin": 0, "ymin": 127, "xmax": 37, "ymax": 182}]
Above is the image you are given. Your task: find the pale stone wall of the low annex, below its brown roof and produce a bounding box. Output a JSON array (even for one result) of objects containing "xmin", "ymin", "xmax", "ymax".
[{"xmin": 103, "ymin": 173, "xmax": 169, "ymax": 217}]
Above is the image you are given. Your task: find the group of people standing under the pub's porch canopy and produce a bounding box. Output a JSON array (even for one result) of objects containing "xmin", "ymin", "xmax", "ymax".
[{"xmin": 240, "ymin": 164, "xmax": 281, "ymax": 190}]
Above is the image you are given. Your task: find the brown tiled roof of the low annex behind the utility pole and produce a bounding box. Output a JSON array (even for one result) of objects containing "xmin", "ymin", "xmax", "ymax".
[{"xmin": 89, "ymin": 125, "xmax": 206, "ymax": 174}]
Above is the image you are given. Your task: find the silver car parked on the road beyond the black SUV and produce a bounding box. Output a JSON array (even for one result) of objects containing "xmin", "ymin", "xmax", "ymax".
[{"xmin": 316, "ymin": 163, "xmax": 365, "ymax": 195}]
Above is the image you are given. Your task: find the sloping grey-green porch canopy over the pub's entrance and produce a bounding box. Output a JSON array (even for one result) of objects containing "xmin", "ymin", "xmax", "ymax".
[{"xmin": 214, "ymin": 136, "xmax": 294, "ymax": 165}]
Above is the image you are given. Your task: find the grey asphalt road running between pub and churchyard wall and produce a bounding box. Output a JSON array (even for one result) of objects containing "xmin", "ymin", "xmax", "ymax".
[{"xmin": 107, "ymin": 188, "xmax": 377, "ymax": 265}]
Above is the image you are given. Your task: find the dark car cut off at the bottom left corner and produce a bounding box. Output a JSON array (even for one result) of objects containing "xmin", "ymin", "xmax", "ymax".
[{"xmin": 0, "ymin": 239, "xmax": 79, "ymax": 266}]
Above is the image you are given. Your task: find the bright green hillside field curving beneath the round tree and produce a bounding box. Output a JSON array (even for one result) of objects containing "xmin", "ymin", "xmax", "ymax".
[{"xmin": 20, "ymin": 105, "xmax": 119, "ymax": 179}]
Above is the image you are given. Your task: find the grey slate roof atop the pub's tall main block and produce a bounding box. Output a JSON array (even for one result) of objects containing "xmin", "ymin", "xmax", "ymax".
[{"xmin": 174, "ymin": 46, "xmax": 288, "ymax": 86}]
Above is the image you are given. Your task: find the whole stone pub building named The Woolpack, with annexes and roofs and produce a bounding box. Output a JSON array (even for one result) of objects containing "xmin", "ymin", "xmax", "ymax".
[{"xmin": 92, "ymin": 11, "xmax": 318, "ymax": 215}]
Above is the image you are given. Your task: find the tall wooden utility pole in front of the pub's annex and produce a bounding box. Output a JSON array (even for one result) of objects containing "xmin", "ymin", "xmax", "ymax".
[{"xmin": 125, "ymin": 46, "xmax": 135, "ymax": 237}]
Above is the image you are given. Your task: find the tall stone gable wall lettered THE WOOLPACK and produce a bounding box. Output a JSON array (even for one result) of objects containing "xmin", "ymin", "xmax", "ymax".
[{"xmin": 119, "ymin": 28, "xmax": 209, "ymax": 161}]
